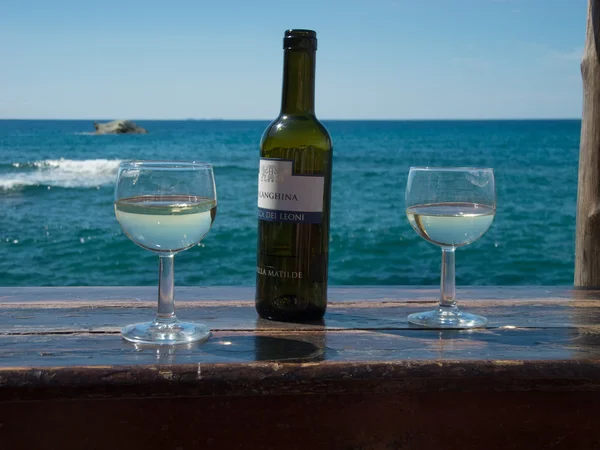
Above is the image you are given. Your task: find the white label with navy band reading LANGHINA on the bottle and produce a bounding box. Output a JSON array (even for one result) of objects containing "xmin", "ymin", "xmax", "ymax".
[{"xmin": 258, "ymin": 158, "xmax": 325, "ymax": 223}]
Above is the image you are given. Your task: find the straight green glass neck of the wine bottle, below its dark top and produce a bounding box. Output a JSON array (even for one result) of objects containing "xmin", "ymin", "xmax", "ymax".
[{"xmin": 281, "ymin": 49, "xmax": 316, "ymax": 115}]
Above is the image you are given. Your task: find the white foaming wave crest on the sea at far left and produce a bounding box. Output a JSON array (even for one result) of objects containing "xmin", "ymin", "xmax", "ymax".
[{"xmin": 0, "ymin": 158, "xmax": 121, "ymax": 190}]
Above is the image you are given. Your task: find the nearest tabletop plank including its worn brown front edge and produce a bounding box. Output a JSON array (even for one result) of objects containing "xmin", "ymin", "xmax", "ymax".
[{"xmin": 0, "ymin": 329, "xmax": 600, "ymax": 400}]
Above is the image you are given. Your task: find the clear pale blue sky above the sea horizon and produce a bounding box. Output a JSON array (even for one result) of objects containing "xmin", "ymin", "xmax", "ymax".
[{"xmin": 0, "ymin": 0, "xmax": 587, "ymax": 120}]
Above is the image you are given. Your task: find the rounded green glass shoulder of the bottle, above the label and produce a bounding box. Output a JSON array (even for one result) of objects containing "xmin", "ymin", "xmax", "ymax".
[{"xmin": 260, "ymin": 115, "xmax": 332, "ymax": 150}]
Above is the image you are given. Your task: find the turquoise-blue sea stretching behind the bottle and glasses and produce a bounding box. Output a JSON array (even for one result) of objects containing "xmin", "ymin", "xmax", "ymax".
[{"xmin": 0, "ymin": 120, "xmax": 581, "ymax": 286}]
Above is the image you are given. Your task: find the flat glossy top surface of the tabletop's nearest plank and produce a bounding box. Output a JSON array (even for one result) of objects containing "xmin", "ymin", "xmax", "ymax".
[{"xmin": 0, "ymin": 327, "xmax": 600, "ymax": 368}]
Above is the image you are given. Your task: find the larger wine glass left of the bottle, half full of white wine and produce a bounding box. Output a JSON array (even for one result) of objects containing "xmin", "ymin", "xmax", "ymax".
[{"xmin": 115, "ymin": 161, "xmax": 217, "ymax": 344}]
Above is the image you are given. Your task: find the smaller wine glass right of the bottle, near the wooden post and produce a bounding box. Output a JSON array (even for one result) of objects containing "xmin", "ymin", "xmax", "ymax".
[{"xmin": 405, "ymin": 167, "xmax": 496, "ymax": 328}]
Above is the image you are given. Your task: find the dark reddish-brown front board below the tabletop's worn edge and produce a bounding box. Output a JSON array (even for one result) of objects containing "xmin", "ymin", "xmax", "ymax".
[{"xmin": 0, "ymin": 392, "xmax": 600, "ymax": 450}]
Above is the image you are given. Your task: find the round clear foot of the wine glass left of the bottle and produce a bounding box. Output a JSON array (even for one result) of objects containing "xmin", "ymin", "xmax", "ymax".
[{"xmin": 121, "ymin": 321, "xmax": 210, "ymax": 345}]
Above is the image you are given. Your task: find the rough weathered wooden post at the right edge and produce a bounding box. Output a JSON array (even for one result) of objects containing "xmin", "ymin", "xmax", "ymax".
[{"xmin": 575, "ymin": 0, "xmax": 600, "ymax": 287}]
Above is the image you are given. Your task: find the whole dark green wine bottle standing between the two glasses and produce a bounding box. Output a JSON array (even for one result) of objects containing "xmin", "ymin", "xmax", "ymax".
[{"xmin": 256, "ymin": 30, "xmax": 333, "ymax": 321}]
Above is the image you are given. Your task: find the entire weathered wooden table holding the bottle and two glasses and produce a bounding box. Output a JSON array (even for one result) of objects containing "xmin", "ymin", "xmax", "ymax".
[{"xmin": 0, "ymin": 287, "xmax": 600, "ymax": 450}]
